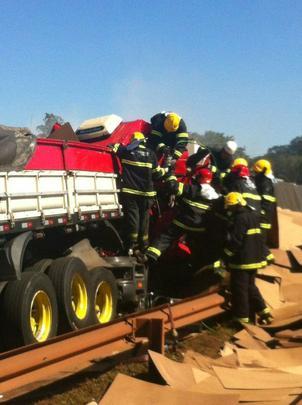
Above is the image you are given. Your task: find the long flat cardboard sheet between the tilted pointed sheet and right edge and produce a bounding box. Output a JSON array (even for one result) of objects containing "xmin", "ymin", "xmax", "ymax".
[{"xmin": 213, "ymin": 366, "xmax": 302, "ymax": 390}]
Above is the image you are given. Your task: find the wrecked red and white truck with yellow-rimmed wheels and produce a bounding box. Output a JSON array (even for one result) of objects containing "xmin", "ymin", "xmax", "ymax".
[{"xmin": 0, "ymin": 116, "xmax": 153, "ymax": 350}]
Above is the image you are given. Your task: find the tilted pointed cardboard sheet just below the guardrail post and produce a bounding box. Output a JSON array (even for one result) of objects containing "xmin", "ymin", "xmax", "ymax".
[{"xmin": 148, "ymin": 350, "xmax": 210, "ymax": 389}]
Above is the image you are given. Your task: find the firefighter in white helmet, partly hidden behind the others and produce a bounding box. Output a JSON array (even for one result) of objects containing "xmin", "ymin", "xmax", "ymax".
[{"xmin": 187, "ymin": 141, "xmax": 237, "ymax": 181}]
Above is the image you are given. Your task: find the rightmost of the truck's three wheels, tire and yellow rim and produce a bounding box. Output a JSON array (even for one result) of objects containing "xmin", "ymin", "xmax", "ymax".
[{"xmin": 89, "ymin": 267, "xmax": 118, "ymax": 324}]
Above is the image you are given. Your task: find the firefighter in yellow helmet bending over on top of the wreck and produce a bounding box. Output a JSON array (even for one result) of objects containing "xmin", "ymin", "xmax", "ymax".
[{"xmin": 147, "ymin": 112, "xmax": 189, "ymax": 165}]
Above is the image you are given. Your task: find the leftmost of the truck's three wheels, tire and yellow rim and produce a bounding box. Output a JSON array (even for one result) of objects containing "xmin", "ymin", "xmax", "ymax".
[{"xmin": 1, "ymin": 272, "xmax": 58, "ymax": 348}]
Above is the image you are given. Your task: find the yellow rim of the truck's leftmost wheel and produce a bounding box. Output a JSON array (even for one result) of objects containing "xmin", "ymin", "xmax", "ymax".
[{"xmin": 30, "ymin": 290, "xmax": 52, "ymax": 342}]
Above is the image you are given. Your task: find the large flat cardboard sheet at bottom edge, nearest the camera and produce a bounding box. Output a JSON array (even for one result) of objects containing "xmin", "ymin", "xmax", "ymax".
[{"xmin": 100, "ymin": 374, "xmax": 239, "ymax": 405}]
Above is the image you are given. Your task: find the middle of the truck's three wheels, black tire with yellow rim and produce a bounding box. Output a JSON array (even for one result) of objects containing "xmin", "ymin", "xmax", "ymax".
[{"xmin": 47, "ymin": 257, "xmax": 91, "ymax": 332}]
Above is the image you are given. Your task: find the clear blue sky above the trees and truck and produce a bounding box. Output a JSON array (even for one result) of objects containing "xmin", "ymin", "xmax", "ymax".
[{"xmin": 0, "ymin": 0, "xmax": 302, "ymax": 155}]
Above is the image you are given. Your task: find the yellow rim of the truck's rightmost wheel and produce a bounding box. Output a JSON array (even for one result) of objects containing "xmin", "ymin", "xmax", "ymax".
[{"xmin": 94, "ymin": 281, "xmax": 113, "ymax": 323}]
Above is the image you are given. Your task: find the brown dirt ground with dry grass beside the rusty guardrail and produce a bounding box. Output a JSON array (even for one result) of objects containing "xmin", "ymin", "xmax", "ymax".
[{"xmin": 9, "ymin": 315, "xmax": 238, "ymax": 405}]
